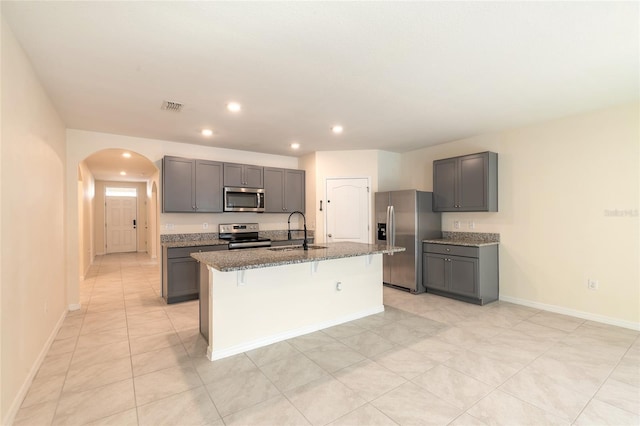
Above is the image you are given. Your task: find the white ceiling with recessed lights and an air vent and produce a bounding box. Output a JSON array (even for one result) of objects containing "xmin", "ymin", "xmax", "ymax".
[{"xmin": 1, "ymin": 1, "xmax": 640, "ymax": 176}]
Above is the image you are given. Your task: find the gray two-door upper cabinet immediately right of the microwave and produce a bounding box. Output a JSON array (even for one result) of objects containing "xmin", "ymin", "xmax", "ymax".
[{"xmin": 264, "ymin": 167, "xmax": 305, "ymax": 213}]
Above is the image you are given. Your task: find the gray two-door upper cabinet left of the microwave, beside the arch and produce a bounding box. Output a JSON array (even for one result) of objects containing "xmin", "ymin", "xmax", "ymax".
[{"xmin": 162, "ymin": 156, "xmax": 222, "ymax": 213}]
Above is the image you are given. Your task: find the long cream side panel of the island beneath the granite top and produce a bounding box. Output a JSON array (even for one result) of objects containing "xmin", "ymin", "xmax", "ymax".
[{"xmin": 207, "ymin": 254, "xmax": 384, "ymax": 360}]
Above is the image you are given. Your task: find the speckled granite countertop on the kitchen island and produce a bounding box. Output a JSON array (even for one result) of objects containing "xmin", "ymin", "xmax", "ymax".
[{"xmin": 191, "ymin": 242, "xmax": 405, "ymax": 272}]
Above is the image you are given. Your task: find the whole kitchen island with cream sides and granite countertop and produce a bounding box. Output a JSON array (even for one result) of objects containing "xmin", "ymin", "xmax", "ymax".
[{"xmin": 191, "ymin": 242, "xmax": 404, "ymax": 360}]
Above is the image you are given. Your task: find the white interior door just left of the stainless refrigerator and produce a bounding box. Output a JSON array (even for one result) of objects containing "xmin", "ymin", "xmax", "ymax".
[{"xmin": 325, "ymin": 178, "xmax": 371, "ymax": 244}]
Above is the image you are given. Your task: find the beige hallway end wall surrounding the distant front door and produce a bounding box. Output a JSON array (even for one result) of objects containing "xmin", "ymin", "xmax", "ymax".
[{"xmin": 93, "ymin": 180, "xmax": 149, "ymax": 255}]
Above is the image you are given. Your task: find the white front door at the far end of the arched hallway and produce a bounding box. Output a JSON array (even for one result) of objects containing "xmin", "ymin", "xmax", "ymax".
[{"xmin": 105, "ymin": 197, "xmax": 138, "ymax": 253}]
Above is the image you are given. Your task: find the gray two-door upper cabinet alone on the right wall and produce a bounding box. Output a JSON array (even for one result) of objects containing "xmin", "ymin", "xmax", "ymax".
[{"xmin": 433, "ymin": 152, "xmax": 498, "ymax": 212}]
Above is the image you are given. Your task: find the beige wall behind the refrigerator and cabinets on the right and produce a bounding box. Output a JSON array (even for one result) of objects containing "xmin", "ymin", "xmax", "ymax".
[{"xmin": 402, "ymin": 104, "xmax": 640, "ymax": 328}]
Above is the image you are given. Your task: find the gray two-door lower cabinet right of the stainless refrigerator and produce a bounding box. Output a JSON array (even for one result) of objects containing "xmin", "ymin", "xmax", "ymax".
[{"xmin": 422, "ymin": 243, "xmax": 499, "ymax": 305}]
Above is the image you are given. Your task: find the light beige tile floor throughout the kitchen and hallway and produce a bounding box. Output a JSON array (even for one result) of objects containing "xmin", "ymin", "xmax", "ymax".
[{"xmin": 14, "ymin": 254, "xmax": 640, "ymax": 426}]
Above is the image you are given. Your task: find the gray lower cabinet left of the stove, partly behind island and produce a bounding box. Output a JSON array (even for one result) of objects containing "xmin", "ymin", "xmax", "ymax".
[{"xmin": 162, "ymin": 245, "xmax": 227, "ymax": 304}]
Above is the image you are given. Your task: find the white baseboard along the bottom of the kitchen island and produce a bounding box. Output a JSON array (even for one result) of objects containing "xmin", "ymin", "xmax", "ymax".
[{"xmin": 207, "ymin": 305, "xmax": 384, "ymax": 361}]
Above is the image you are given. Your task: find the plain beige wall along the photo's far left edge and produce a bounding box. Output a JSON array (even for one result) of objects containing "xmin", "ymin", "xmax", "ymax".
[{"xmin": 0, "ymin": 15, "xmax": 67, "ymax": 424}]
